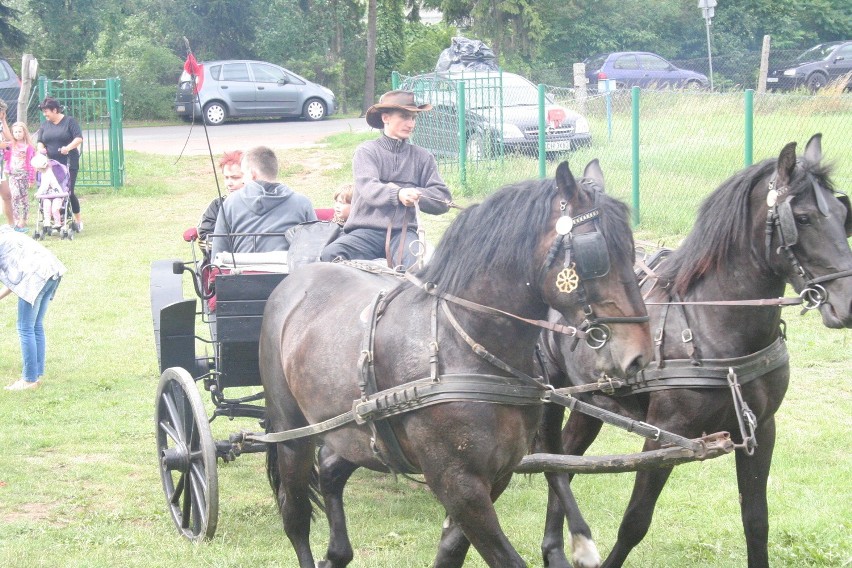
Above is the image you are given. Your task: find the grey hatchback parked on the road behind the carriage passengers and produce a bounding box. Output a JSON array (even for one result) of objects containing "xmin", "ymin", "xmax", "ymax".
[{"xmin": 175, "ymin": 60, "xmax": 337, "ymax": 125}]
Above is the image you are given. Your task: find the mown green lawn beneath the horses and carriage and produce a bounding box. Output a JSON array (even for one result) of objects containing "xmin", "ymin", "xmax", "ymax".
[{"xmin": 0, "ymin": 126, "xmax": 852, "ymax": 568}]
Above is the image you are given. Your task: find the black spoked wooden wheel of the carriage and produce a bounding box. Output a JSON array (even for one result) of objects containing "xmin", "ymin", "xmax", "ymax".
[{"xmin": 155, "ymin": 367, "xmax": 219, "ymax": 541}]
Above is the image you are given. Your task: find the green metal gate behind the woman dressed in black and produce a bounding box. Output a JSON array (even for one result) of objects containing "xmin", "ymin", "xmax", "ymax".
[{"xmin": 38, "ymin": 77, "xmax": 124, "ymax": 187}]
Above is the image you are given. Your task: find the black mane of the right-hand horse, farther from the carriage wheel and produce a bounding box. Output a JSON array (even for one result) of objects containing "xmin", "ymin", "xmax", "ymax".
[{"xmin": 658, "ymin": 158, "xmax": 834, "ymax": 296}]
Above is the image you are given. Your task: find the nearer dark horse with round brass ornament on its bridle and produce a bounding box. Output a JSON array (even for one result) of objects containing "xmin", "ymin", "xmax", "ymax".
[{"xmin": 260, "ymin": 161, "xmax": 652, "ymax": 568}]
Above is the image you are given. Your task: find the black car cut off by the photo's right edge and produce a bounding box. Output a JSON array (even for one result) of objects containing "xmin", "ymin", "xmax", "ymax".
[{"xmin": 766, "ymin": 41, "xmax": 852, "ymax": 92}]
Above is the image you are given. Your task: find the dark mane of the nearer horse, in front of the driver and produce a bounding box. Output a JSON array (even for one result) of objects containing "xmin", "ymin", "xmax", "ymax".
[{"xmin": 418, "ymin": 179, "xmax": 633, "ymax": 294}]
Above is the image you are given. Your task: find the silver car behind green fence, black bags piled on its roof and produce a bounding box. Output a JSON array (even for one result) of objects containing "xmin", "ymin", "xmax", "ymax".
[{"xmin": 400, "ymin": 71, "xmax": 592, "ymax": 160}]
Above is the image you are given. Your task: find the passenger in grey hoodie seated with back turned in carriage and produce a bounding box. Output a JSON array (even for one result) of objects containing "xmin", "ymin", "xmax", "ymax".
[{"xmin": 212, "ymin": 146, "xmax": 317, "ymax": 259}]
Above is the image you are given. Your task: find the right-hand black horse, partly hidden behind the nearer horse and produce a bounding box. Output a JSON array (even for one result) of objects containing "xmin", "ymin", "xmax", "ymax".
[{"xmin": 541, "ymin": 135, "xmax": 852, "ymax": 567}]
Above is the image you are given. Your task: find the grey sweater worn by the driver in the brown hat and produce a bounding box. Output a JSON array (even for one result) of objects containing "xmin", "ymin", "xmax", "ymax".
[{"xmin": 343, "ymin": 134, "xmax": 452, "ymax": 232}]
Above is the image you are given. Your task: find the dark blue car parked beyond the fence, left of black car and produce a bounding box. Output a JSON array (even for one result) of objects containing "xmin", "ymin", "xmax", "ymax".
[{"xmin": 583, "ymin": 51, "xmax": 710, "ymax": 91}]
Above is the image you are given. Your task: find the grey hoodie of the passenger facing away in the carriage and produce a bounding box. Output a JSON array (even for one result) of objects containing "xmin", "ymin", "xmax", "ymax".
[{"xmin": 212, "ymin": 181, "xmax": 317, "ymax": 258}]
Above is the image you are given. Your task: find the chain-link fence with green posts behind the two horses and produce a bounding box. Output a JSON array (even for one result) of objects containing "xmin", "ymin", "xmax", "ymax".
[{"xmin": 394, "ymin": 71, "xmax": 852, "ymax": 242}]
